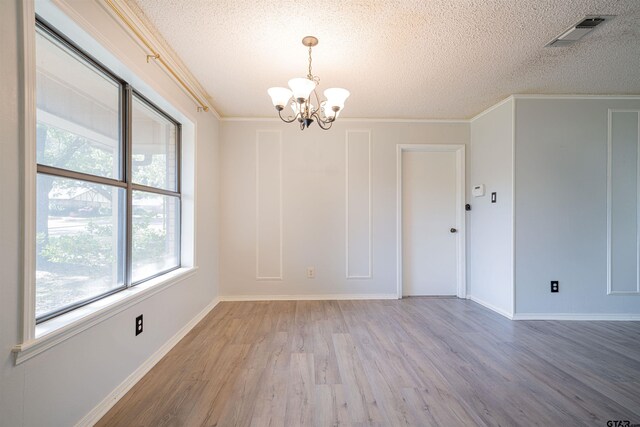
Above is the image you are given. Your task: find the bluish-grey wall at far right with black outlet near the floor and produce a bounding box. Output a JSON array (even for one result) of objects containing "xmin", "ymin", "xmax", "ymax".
[{"xmin": 515, "ymin": 98, "xmax": 640, "ymax": 316}]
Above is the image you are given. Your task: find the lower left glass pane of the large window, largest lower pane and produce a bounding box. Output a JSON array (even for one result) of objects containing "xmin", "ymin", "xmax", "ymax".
[{"xmin": 36, "ymin": 174, "xmax": 125, "ymax": 318}]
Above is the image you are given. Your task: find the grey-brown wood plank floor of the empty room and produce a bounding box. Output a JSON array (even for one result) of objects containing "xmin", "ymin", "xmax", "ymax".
[{"xmin": 97, "ymin": 298, "xmax": 640, "ymax": 427}]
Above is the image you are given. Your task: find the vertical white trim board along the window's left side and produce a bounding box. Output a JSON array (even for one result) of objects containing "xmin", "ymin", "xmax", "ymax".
[{"xmin": 21, "ymin": 0, "xmax": 36, "ymax": 342}]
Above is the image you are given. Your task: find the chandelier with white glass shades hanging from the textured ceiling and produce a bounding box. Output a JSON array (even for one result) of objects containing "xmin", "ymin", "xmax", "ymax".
[{"xmin": 267, "ymin": 36, "xmax": 349, "ymax": 130}]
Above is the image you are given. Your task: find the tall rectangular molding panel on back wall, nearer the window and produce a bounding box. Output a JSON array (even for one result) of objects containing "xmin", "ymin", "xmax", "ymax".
[{"xmin": 256, "ymin": 130, "xmax": 283, "ymax": 280}]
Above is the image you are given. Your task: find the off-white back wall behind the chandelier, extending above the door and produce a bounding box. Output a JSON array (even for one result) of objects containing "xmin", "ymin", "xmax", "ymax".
[{"xmin": 220, "ymin": 120, "xmax": 469, "ymax": 297}]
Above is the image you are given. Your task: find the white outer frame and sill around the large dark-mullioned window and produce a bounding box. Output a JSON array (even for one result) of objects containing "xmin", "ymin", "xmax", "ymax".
[{"xmin": 13, "ymin": 0, "xmax": 197, "ymax": 364}]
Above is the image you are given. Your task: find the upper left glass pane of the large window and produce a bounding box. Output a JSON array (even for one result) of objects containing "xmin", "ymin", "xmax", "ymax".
[{"xmin": 36, "ymin": 30, "xmax": 121, "ymax": 179}]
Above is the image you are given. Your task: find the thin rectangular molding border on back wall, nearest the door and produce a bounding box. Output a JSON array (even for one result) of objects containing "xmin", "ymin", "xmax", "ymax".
[{"xmin": 345, "ymin": 129, "xmax": 373, "ymax": 279}]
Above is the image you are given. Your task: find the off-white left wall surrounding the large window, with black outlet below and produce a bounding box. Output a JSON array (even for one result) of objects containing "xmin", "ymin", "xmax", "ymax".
[{"xmin": 0, "ymin": 0, "xmax": 219, "ymax": 427}]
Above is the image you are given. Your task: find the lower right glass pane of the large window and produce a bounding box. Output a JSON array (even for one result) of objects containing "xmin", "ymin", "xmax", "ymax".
[{"xmin": 132, "ymin": 191, "xmax": 180, "ymax": 282}]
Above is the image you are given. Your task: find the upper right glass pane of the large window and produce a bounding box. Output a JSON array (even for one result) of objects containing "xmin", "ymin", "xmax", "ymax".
[{"xmin": 132, "ymin": 96, "xmax": 178, "ymax": 191}]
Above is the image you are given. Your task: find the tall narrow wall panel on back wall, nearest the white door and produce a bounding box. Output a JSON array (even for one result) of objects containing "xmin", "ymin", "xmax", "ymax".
[{"xmin": 345, "ymin": 130, "xmax": 372, "ymax": 279}]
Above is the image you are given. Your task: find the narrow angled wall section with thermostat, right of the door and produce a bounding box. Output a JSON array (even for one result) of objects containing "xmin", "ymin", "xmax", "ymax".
[{"xmin": 467, "ymin": 98, "xmax": 514, "ymax": 316}]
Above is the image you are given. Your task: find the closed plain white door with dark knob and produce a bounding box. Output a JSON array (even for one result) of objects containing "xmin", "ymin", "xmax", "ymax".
[{"xmin": 401, "ymin": 151, "xmax": 458, "ymax": 296}]
